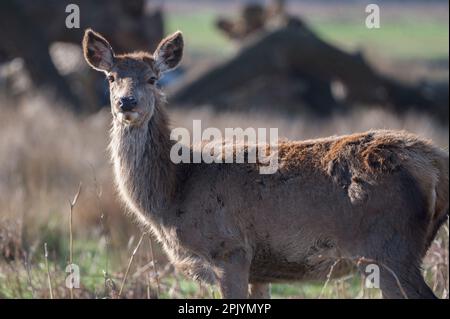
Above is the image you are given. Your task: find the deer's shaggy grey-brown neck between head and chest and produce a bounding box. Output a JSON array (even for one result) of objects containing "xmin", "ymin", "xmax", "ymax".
[{"xmin": 110, "ymin": 106, "xmax": 175, "ymax": 222}]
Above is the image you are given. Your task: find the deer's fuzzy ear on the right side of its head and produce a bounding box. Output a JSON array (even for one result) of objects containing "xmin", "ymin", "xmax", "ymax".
[{"xmin": 153, "ymin": 31, "xmax": 184, "ymax": 73}]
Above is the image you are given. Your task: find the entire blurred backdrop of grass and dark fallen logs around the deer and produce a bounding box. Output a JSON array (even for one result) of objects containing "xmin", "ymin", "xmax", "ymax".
[{"xmin": 0, "ymin": 0, "xmax": 449, "ymax": 298}]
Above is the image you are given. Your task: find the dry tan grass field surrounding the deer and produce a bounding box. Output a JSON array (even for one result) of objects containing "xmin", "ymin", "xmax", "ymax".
[{"xmin": 0, "ymin": 98, "xmax": 449, "ymax": 298}]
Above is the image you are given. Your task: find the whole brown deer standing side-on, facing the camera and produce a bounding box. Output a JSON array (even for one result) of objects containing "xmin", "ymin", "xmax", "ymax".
[{"xmin": 82, "ymin": 29, "xmax": 449, "ymax": 299}]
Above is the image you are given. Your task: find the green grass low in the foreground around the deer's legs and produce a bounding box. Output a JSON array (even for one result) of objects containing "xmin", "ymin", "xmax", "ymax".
[{"xmin": 0, "ymin": 232, "xmax": 372, "ymax": 299}]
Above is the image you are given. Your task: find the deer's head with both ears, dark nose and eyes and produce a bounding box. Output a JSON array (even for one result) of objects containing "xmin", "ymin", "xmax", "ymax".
[{"xmin": 83, "ymin": 29, "xmax": 183, "ymax": 126}]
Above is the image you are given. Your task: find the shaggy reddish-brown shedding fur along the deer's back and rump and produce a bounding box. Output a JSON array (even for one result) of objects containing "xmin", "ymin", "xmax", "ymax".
[{"xmin": 279, "ymin": 130, "xmax": 448, "ymax": 208}]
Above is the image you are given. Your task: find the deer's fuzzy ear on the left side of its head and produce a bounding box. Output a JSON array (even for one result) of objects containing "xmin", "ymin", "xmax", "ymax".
[{"xmin": 83, "ymin": 29, "xmax": 114, "ymax": 72}]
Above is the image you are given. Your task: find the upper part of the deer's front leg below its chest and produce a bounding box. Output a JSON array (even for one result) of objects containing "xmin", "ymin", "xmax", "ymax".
[{"xmin": 216, "ymin": 249, "xmax": 250, "ymax": 299}]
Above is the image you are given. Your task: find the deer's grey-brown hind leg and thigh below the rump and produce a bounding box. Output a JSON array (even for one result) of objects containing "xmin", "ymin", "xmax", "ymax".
[{"xmin": 349, "ymin": 169, "xmax": 436, "ymax": 299}]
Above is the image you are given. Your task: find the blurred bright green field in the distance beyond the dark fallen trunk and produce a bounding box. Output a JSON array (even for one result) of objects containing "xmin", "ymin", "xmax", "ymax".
[{"xmin": 166, "ymin": 10, "xmax": 449, "ymax": 59}]
